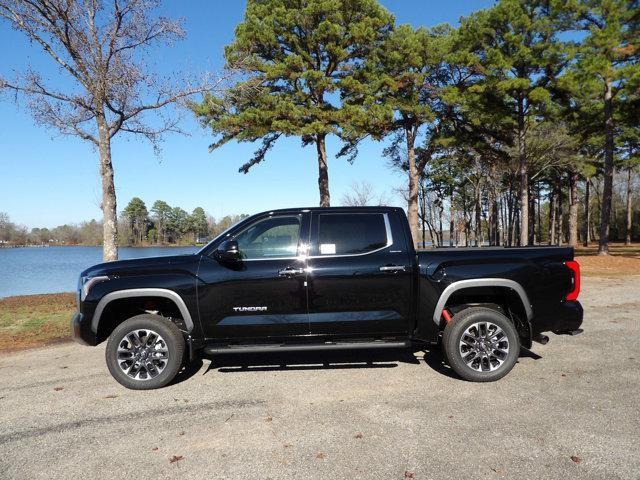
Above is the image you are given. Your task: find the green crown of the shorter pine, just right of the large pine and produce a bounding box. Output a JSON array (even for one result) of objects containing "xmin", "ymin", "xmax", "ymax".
[{"xmin": 341, "ymin": 25, "xmax": 452, "ymax": 162}]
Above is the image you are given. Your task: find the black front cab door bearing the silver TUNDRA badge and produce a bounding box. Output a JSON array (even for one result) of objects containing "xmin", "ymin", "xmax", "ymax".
[{"xmin": 198, "ymin": 213, "xmax": 309, "ymax": 341}]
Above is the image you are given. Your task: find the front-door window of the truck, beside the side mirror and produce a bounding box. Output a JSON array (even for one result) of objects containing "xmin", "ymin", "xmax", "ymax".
[{"xmin": 235, "ymin": 215, "xmax": 301, "ymax": 260}]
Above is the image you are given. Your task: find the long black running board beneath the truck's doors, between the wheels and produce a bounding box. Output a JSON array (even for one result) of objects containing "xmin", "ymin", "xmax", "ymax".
[{"xmin": 203, "ymin": 340, "xmax": 411, "ymax": 355}]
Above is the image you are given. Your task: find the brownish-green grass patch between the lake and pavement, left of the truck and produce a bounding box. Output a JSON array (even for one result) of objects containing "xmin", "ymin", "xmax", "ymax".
[{"xmin": 0, "ymin": 293, "xmax": 76, "ymax": 350}]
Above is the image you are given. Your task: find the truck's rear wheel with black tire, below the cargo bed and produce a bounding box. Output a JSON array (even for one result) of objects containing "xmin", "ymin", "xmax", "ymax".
[{"xmin": 442, "ymin": 307, "xmax": 520, "ymax": 382}]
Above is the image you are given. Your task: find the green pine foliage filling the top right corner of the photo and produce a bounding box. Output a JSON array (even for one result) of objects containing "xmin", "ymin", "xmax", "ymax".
[{"xmin": 554, "ymin": 0, "xmax": 640, "ymax": 155}]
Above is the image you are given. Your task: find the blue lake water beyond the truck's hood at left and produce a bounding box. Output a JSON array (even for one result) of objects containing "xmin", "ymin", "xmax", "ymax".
[{"xmin": 0, "ymin": 247, "xmax": 198, "ymax": 298}]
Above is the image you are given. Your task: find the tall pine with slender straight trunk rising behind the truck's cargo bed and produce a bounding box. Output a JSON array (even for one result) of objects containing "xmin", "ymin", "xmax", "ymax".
[{"xmin": 460, "ymin": 0, "xmax": 566, "ymax": 245}]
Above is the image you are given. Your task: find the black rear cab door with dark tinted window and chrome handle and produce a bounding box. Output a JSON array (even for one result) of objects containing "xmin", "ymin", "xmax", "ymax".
[{"xmin": 307, "ymin": 209, "xmax": 413, "ymax": 337}]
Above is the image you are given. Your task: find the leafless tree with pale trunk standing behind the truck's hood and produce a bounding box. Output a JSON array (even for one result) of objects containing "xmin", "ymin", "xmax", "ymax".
[{"xmin": 0, "ymin": 0, "xmax": 221, "ymax": 261}]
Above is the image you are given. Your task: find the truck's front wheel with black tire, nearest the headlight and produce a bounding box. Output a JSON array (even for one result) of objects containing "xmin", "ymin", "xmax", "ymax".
[{"xmin": 105, "ymin": 314, "xmax": 185, "ymax": 390}]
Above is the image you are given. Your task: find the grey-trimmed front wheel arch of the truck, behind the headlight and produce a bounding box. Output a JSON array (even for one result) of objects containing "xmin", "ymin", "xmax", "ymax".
[{"xmin": 91, "ymin": 288, "xmax": 194, "ymax": 341}]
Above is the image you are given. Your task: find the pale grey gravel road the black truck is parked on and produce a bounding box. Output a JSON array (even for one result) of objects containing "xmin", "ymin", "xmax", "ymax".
[{"xmin": 0, "ymin": 276, "xmax": 640, "ymax": 480}]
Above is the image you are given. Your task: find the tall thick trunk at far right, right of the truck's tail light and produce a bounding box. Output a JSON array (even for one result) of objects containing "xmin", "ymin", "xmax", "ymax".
[{"xmin": 598, "ymin": 80, "xmax": 614, "ymax": 255}]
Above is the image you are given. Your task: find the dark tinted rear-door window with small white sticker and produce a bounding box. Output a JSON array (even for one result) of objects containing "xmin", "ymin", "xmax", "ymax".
[{"xmin": 318, "ymin": 213, "xmax": 390, "ymax": 255}]
